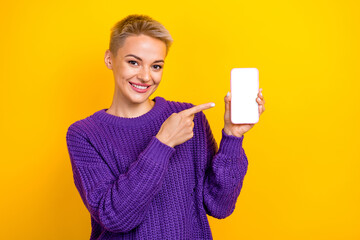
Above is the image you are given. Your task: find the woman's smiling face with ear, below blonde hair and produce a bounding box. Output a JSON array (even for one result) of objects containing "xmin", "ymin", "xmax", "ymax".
[{"xmin": 105, "ymin": 34, "xmax": 166, "ymax": 105}]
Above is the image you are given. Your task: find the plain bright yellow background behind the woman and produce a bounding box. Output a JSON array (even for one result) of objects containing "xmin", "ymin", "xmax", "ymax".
[{"xmin": 0, "ymin": 0, "xmax": 360, "ymax": 239}]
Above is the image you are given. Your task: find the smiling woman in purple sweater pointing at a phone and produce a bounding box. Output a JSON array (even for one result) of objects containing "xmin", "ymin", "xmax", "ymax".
[{"xmin": 66, "ymin": 15, "xmax": 265, "ymax": 239}]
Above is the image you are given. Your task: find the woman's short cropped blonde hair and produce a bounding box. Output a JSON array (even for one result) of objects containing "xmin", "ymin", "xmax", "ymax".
[{"xmin": 109, "ymin": 14, "xmax": 173, "ymax": 57}]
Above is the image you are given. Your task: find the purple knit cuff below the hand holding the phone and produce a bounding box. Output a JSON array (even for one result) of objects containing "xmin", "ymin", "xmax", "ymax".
[{"xmin": 218, "ymin": 129, "xmax": 244, "ymax": 157}]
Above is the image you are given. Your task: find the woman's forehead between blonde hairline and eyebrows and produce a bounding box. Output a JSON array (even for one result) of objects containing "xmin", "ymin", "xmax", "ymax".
[{"xmin": 118, "ymin": 34, "xmax": 166, "ymax": 59}]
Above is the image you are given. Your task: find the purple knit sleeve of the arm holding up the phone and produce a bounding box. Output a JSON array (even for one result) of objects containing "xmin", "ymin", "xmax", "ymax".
[{"xmin": 203, "ymin": 112, "xmax": 248, "ymax": 219}]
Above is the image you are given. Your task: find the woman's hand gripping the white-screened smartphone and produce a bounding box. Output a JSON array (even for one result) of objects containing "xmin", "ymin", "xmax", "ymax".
[{"xmin": 224, "ymin": 88, "xmax": 265, "ymax": 137}]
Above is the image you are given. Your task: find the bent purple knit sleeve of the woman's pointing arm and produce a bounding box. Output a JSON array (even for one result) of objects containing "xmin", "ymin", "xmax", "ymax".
[{"xmin": 66, "ymin": 125, "xmax": 175, "ymax": 232}]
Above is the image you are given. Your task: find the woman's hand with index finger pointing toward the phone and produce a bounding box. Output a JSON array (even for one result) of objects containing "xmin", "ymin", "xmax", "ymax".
[{"xmin": 156, "ymin": 102, "xmax": 215, "ymax": 147}]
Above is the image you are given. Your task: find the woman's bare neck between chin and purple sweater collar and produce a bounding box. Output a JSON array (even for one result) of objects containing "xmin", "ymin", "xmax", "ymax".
[{"xmin": 106, "ymin": 93, "xmax": 155, "ymax": 118}]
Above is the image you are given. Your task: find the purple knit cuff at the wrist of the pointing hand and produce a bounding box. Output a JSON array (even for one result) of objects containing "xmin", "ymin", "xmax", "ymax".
[{"xmin": 142, "ymin": 136, "xmax": 175, "ymax": 161}]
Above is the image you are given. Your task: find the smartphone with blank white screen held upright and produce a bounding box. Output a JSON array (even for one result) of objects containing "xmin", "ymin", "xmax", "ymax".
[{"xmin": 230, "ymin": 68, "xmax": 259, "ymax": 124}]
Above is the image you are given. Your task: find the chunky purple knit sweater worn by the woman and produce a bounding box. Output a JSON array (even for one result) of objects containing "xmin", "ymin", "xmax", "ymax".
[{"xmin": 66, "ymin": 97, "xmax": 248, "ymax": 240}]
